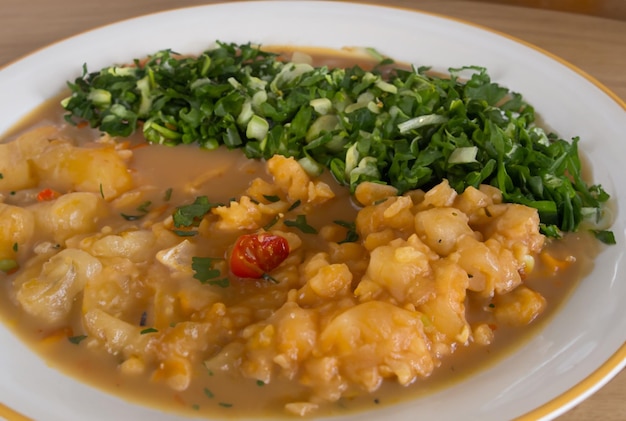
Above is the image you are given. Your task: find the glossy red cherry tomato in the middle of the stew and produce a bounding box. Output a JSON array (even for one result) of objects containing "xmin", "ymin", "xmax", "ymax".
[{"xmin": 229, "ymin": 233, "xmax": 289, "ymax": 278}]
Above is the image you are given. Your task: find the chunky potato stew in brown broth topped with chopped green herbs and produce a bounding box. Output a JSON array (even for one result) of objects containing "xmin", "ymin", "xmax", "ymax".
[{"xmin": 0, "ymin": 44, "xmax": 611, "ymax": 416}]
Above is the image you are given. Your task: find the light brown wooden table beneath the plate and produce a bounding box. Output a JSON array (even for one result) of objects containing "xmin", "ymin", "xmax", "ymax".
[{"xmin": 0, "ymin": 0, "xmax": 626, "ymax": 421}]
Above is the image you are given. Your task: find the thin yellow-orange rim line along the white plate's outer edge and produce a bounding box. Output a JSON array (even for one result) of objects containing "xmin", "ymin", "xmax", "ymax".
[{"xmin": 0, "ymin": 0, "xmax": 626, "ymax": 421}]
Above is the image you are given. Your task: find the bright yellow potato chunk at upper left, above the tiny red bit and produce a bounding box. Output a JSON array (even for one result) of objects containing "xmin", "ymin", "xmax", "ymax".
[{"xmin": 34, "ymin": 142, "xmax": 133, "ymax": 200}]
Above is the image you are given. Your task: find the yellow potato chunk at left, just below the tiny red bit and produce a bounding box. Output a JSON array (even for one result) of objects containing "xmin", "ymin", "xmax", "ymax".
[{"xmin": 31, "ymin": 192, "xmax": 106, "ymax": 243}]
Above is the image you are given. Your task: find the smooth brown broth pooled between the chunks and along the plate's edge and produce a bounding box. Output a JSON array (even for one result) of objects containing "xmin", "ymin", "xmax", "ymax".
[{"xmin": 0, "ymin": 49, "xmax": 599, "ymax": 419}]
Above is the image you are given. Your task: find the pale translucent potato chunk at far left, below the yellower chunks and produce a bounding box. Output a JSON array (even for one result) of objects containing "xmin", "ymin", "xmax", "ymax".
[{"xmin": 14, "ymin": 249, "xmax": 102, "ymax": 326}]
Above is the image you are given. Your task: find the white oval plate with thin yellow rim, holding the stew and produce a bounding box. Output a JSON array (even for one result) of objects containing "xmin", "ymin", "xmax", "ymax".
[{"xmin": 0, "ymin": 1, "xmax": 626, "ymax": 421}]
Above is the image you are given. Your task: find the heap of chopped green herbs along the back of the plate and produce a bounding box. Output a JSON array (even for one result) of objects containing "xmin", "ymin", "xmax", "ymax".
[{"xmin": 62, "ymin": 43, "xmax": 614, "ymax": 242}]
